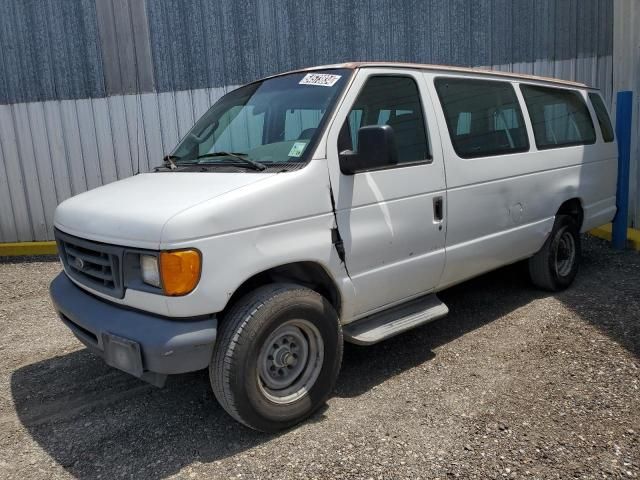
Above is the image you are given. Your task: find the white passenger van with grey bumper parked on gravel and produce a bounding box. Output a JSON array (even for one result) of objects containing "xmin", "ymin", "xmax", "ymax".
[{"xmin": 51, "ymin": 63, "xmax": 617, "ymax": 431}]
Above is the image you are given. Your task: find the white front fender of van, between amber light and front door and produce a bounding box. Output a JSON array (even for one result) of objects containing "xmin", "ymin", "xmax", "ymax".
[{"xmin": 160, "ymin": 160, "xmax": 353, "ymax": 317}]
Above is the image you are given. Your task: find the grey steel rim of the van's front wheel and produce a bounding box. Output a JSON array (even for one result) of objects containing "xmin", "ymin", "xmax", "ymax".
[{"xmin": 258, "ymin": 320, "xmax": 324, "ymax": 404}]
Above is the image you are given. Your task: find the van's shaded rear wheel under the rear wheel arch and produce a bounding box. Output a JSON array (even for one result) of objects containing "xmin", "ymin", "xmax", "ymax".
[{"xmin": 529, "ymin": 215, "xmax": 582, "ymax": 292}]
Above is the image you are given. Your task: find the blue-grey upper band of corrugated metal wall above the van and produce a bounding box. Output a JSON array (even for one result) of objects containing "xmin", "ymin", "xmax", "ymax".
[{"xmin": 0, "ymin": 0, "xmax": 616, "ymax": 103}]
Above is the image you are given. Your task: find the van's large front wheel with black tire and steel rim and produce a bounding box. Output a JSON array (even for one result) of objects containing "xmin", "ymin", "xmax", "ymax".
[{"xmin": 209, "ymin": 283, "xmax": 343, "ymax": 432}]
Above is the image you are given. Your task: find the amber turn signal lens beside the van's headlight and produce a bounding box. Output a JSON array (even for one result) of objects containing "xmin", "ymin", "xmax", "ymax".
[{"xmin": 160, "ymin": 250, "xmax": 202, "ymax": 296}]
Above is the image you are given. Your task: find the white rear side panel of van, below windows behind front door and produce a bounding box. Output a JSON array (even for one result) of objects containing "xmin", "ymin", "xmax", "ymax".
[{"xmin": 439, "ymin": 158, "xmax": 615, "ymax": 288}]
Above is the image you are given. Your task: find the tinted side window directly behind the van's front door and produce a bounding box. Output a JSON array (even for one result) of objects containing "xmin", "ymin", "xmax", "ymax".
[{"xmin": 435, "ymin": 78, "xmax": 529, "ymax": 158}]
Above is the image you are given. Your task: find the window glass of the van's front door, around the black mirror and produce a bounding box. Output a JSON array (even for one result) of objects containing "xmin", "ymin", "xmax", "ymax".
[{"xmin": 338, "ymin": 75, "xmax": 431, "ymax": 164}]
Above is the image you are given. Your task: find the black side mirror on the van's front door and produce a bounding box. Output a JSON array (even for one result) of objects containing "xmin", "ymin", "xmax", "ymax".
[{"xmin": 340, "ymin": 125, "xmax": 398, "ymax": 175}]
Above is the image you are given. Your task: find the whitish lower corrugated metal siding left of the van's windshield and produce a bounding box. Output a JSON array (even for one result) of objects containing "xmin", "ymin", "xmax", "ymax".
[{"xmin": 0, "ymin": 88, "xmax": 232, "ymax": 242}]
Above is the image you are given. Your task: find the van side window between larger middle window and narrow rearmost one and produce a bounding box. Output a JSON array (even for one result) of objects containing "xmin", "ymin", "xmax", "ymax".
[{"xmin": 521, "ymin": 85, "xmax": 596, "ymax": 150}]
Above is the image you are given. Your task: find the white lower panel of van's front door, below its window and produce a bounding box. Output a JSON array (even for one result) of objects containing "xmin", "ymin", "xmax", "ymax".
[{"xmin": 337, "ymin": 165, "xmax": 444, "ymax": 314}]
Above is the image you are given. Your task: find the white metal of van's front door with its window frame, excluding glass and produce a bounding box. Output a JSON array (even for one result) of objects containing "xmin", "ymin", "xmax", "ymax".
[{"xmin": 326, "ymin": 68, "xmax": 446, "ymax": 316}]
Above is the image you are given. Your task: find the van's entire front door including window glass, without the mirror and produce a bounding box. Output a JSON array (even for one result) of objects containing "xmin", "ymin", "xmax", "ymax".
[{"xmin": 327, "ymin": 69, "xmax": 446, "ymax": 317}]
